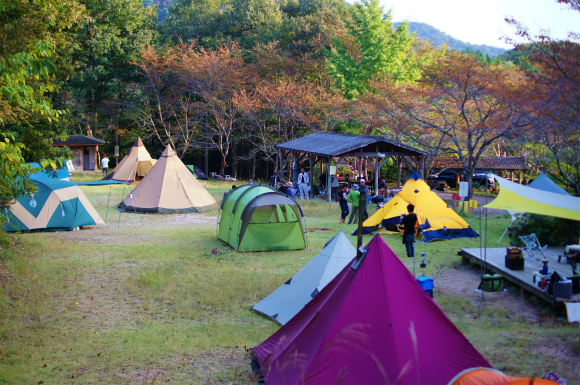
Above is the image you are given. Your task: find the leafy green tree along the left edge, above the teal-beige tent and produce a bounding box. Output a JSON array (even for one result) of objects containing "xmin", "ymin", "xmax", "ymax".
[{"xmin": 0, "ymin": 0, "xmax": 82, "ymax": 206}]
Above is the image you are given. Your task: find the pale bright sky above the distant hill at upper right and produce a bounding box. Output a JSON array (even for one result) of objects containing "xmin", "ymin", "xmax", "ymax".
[{"xmin": 380, "ymin": 0, "xmax": 580, "ymax": 49}]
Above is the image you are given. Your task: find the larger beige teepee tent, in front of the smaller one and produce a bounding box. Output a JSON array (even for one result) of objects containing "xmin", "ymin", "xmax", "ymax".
[{"xmin": 119, "ymin": 145, "xmax": 217, "ymax": 214}]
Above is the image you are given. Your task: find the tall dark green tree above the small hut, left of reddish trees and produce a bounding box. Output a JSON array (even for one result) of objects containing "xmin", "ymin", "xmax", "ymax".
[{"xmin": 65, "ymin": 0, "xmax": 157, "ymax": 136}]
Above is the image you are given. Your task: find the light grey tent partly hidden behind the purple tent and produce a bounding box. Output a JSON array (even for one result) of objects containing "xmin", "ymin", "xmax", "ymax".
[{"xmin": 252, "ymin": 230, "xmax": 356, "ymax": 325}]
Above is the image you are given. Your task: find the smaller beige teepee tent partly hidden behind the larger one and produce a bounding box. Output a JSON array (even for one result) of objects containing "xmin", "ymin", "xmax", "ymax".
[{"xmin": 105, "ymin": 138, "xmax": 157, "ymax": 183}]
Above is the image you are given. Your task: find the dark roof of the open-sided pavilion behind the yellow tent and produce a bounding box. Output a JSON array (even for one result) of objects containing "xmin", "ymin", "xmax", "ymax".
[{"xmin": 276, "ymin": 132, "xmax": 429, "ymax": 157}]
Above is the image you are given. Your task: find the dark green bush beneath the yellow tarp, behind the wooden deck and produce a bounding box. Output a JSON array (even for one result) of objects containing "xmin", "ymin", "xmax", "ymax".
[{"xmin": 508, "ymin": 214, "xmax": 580, "ymax": 247}]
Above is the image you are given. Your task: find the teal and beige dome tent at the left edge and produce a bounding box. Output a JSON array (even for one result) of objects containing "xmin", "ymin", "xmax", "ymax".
[{"xmin": 4, "ymin": 178, "xmax": 105, "ymax": 231}]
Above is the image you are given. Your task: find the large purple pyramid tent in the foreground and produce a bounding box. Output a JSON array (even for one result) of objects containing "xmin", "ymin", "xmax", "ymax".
[{"xmin": 252, "ymin": 235, "xmax": 491, "ymax": 385}]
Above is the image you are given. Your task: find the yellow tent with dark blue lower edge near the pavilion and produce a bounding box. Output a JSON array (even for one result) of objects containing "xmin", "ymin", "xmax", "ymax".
[{"xmin": 363, "ymin": 172, "xmax": 478, "ymax": 242}]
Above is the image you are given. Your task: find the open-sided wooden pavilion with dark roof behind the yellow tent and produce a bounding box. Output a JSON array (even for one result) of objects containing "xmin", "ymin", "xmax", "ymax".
[{"xmin": 276, "ymin": 132, "xmax": 429, "ymax": 202}]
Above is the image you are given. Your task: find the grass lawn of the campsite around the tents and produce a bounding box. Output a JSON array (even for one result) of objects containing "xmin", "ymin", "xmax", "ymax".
[{"xmin": 0, "ymin": 174, "xmax": 580, "ymax": 384}]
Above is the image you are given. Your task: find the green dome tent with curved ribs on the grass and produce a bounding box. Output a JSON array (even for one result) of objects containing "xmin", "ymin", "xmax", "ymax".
[{"xmin": 218, "ymin": 185, "xmax": 306, "ymax": 251}]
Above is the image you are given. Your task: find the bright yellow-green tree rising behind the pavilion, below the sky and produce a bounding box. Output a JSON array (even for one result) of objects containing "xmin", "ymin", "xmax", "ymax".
[{"xmin": 325, "ymin": 0, "xmax": 420, "ymax": 99}]
